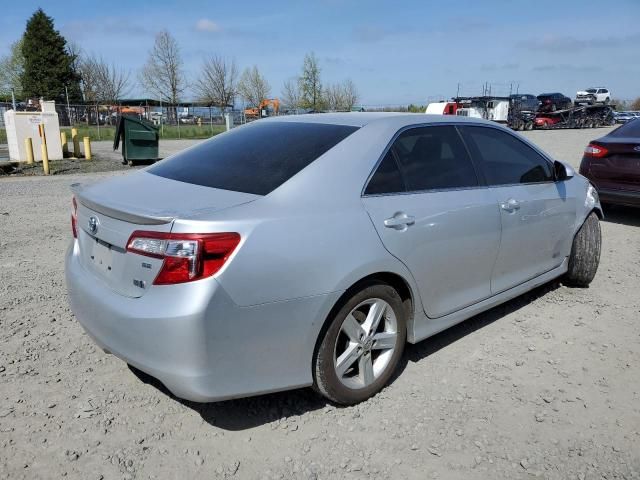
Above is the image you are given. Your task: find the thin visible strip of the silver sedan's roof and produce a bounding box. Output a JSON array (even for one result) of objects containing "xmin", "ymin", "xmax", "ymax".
[{"xmin": 263, "ymin": 112, "xmax": 495, "ymax": 127}]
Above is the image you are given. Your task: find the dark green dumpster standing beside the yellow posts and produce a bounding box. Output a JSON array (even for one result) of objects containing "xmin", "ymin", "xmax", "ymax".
[{"xmin": 113, "ymin": 115, "xmax": 160, "ymax": 165}]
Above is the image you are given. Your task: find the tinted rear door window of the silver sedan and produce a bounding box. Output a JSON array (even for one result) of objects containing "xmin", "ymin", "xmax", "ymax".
[{"xmin": 393, "ymin": 126, "xmax": 478, "ymax": 192}]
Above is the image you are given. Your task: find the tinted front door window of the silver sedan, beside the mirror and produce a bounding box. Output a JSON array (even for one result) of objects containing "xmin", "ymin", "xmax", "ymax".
[{"xmin": 462, "ymin": 126, "xmax": 553, "ymax": 185}]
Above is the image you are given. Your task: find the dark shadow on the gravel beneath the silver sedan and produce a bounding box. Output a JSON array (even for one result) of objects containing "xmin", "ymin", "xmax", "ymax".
[{"xmin": 129, "ymin": 280, "xmax": 560, "ymax": 431}]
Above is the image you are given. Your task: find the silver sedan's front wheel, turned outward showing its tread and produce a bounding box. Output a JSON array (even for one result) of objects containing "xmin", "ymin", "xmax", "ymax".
[{"xmin": 564, "ymin": 212, "xmax": 602, "ymax": 287}]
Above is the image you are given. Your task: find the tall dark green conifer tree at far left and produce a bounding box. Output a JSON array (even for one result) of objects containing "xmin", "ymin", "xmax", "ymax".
[{"xmin": 21, "ymin": 8, "xmax": 82, "ymax": 103}]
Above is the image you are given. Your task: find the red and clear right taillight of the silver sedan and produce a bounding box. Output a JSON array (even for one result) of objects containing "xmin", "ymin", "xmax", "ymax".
[{"xmin": 127, "ymin": 231, "xmax": 240, "ymax": 285}]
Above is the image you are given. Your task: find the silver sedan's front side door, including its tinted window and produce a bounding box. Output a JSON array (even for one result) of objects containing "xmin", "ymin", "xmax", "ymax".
[{"xmin": 461, "ymin": 126, "xmax": 576, "ymax": 294}]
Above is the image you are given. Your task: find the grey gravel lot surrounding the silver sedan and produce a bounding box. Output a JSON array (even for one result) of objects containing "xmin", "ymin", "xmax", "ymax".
[{"xmin": 0, "ymin": 125, "xmax": 640, "ymax": 479}]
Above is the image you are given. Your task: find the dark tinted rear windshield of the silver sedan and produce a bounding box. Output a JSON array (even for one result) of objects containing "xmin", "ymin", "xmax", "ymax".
[{"xmin": 147, "ymin": 121, "xmax": 358, "ymax": 195}]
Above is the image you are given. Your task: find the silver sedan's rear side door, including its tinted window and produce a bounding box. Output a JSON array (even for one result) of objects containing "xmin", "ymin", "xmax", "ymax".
[{"xmin": 363, "ymin": 126, "xmax": 500, "ymax": 318}]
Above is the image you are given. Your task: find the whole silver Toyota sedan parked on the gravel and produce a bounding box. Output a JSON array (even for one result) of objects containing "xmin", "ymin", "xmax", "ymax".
[{"xmin": 66, "ymin": 113, "xmax": 602, "ymax": 404}]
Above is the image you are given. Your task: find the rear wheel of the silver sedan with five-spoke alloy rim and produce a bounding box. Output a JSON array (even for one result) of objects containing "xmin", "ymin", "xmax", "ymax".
[{"xmin": 313, "ymin": 283, "xmax": 407, "ymax": 405}]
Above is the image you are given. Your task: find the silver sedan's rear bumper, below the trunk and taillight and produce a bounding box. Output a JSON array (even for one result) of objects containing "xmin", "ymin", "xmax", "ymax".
[{"xmin": 65, "ymin": 241, "xmax": 339, "ymax": 402}]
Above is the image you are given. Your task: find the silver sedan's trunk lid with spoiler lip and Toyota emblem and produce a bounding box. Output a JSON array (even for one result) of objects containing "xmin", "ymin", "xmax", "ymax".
[{"xmin": 73, "ymin": 171, "xmax": 259, "ymax": 298}]
